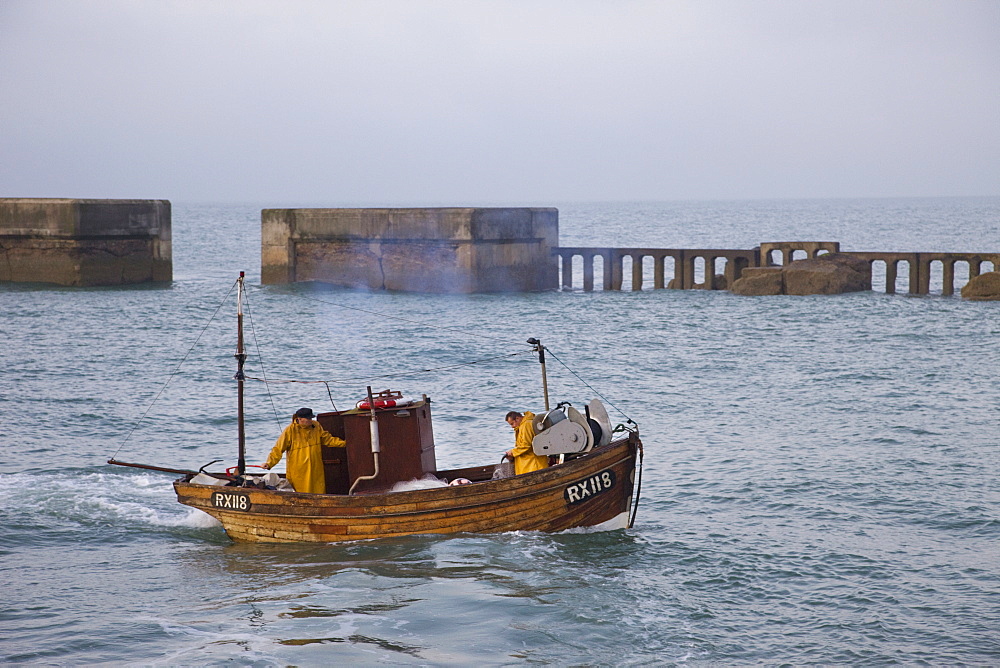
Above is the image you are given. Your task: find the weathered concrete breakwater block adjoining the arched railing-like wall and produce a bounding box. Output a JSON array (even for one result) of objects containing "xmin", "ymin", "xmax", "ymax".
[{"xmin": 261, "ymin": 208, "xmax": 559, "ymax": 293}]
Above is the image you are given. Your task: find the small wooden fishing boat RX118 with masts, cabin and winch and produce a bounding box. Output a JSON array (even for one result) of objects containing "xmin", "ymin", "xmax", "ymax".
[{"xmin": 109, "ymin": 272, "xmax": 642, "ymax": 543}]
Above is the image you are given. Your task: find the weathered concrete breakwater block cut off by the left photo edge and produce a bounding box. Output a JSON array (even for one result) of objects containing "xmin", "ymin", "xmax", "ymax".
[{"xmin": 0, "ymin": 198, "xmax": 173, "ymax": 286}]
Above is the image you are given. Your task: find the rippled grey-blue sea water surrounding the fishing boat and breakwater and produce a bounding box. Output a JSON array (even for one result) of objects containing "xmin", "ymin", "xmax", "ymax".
[{"xmin": 0, "ymin": 198, "xmax": 1000, "ymax": 666}]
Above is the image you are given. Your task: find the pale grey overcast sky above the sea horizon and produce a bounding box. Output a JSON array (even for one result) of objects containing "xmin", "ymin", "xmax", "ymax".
[{"xmin": 0, "ymin": 0, "xmax": 1000, "ymax": 206}]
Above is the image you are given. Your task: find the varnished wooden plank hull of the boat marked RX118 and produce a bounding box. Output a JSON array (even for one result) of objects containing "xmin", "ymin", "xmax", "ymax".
[{"xmin": 174, "ymin": 434, "xmax": 642, "ymax": 543}]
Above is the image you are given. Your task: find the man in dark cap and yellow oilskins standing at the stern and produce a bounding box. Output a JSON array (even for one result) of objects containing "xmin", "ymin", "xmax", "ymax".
[{"xmin": 263, "ymin": 408, "xmax": 347, "ymax": 494}]
